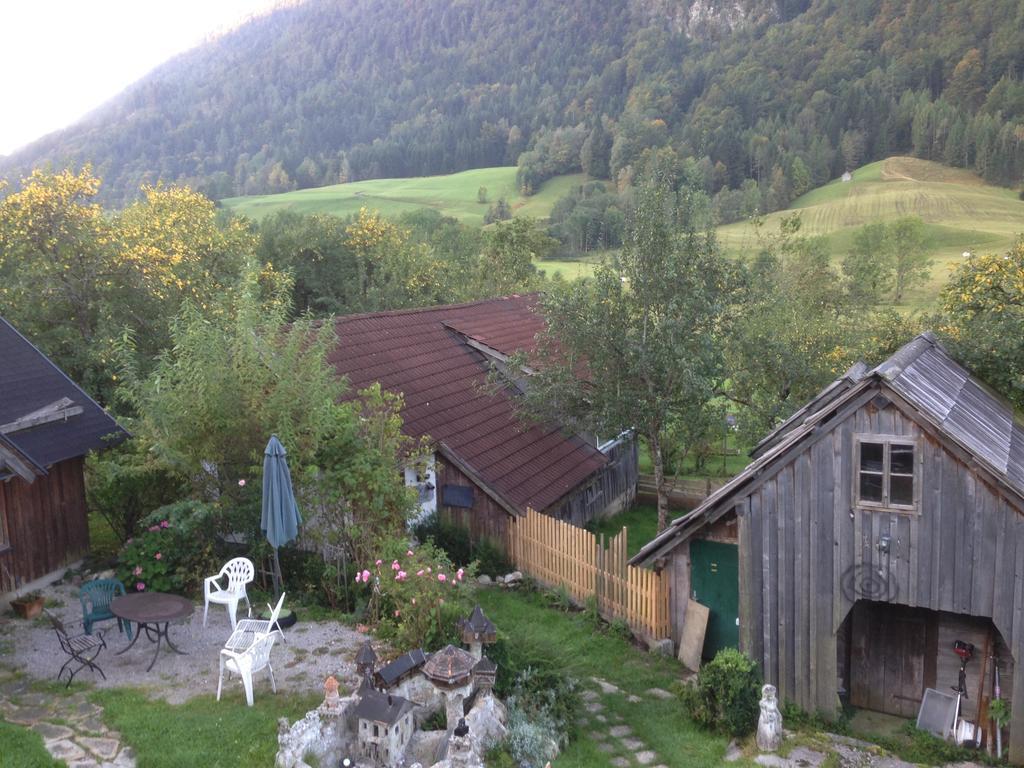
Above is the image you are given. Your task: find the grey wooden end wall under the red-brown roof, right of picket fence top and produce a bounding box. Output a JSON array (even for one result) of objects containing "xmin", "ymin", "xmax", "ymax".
[{"xmin": 539, "ymin": 439, "xmax": 639, "ymax": 527}]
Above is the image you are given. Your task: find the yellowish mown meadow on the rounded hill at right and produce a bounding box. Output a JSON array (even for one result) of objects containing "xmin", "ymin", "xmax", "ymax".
[{"xmin": 718, "ymin": 157, "xmax": 1024, "ymax": 308}]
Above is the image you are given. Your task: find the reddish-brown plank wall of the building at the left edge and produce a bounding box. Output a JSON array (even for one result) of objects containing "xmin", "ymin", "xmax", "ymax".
[{"xmin": 0, "ymin": 458, "xmax": 89, "ymax": 592}]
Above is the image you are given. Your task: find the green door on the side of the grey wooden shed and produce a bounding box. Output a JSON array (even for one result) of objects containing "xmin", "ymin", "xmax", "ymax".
[{"xmin": 690, "ymin": 539, "xmax": 739, "ymax": 658}]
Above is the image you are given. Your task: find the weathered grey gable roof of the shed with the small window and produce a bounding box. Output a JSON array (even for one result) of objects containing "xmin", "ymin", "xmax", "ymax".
[{"xmin": 630, "ymin": 332, "xmax": 1024, "ymax": 564}]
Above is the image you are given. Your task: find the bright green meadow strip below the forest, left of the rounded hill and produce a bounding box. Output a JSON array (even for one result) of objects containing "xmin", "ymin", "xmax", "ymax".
[{"xmin": 221, "ymin": 166, "xmax": 587, "ymax": 225}]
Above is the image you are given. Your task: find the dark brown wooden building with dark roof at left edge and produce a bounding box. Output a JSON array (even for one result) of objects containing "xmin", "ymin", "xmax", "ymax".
[{"xmin": 0, "ymin": 317, "xmax": 127, "ymax": 601}]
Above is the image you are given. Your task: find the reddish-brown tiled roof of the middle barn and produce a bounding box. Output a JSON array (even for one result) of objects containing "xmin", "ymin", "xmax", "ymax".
[{"xmin": 329, "ymin": 295, "xmax": 607, "ymax": 514}]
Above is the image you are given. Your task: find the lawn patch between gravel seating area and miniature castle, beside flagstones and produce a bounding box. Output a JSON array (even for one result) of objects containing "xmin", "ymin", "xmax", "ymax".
[{"xmin": 91, "ymin": 688, "xmax": 322, "ymax": 768}]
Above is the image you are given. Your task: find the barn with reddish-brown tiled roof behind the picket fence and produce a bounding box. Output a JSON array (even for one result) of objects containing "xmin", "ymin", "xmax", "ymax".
[{"xmin": 330, "ymin": 296, "xmax": 637, "ymax": 546}]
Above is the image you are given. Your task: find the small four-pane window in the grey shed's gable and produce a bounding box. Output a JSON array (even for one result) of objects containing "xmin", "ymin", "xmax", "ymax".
[{"xmin": 853, "ymin": 434, "xmax": 921, "ymax": 512}]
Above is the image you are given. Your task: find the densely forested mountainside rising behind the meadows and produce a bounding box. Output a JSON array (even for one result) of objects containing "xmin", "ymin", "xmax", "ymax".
[{"xmin": 0, "ymin": 0, "xmax": 1024, "ymax": 210}]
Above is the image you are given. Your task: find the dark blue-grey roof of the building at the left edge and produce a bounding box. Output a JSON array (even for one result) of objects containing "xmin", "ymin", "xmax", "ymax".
[{"xmin": 0, "ymin": 317, "xmax": 128, "ymax": 481}]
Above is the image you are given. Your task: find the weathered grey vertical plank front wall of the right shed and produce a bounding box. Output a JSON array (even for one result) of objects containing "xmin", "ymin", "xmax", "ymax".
[{"xmin": 735, "ymin": 393, "xmax": 1024, "ymax": 761}]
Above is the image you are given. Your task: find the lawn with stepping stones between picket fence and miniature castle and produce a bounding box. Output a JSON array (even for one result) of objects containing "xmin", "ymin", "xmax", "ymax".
[{"xmin": 479, "ymin": 589, "xmax": 751, "ymax": 768}]
